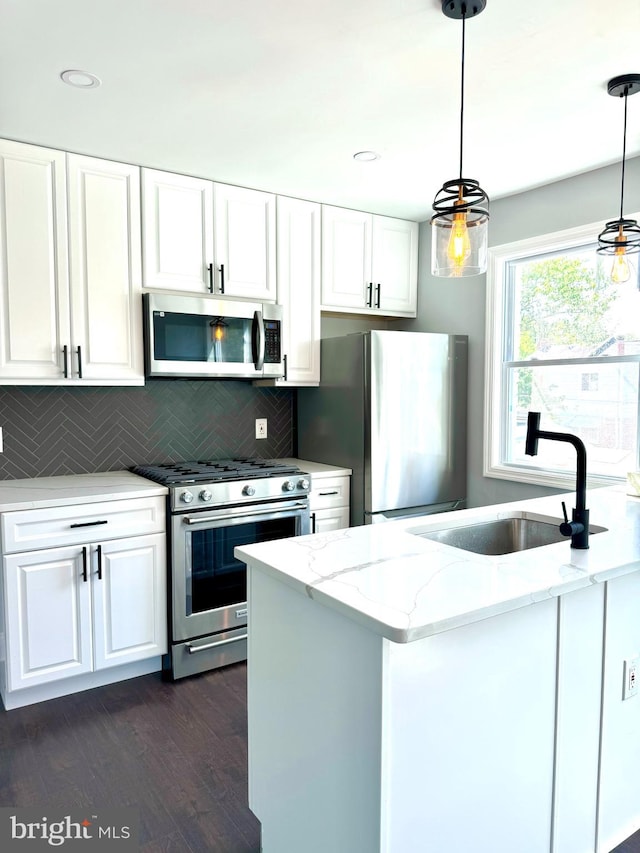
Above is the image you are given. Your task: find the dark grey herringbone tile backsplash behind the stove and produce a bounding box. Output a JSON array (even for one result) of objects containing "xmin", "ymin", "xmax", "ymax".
[{"xmin": 0, "ymin": 380, "xmax": 294, "ymax": 480}]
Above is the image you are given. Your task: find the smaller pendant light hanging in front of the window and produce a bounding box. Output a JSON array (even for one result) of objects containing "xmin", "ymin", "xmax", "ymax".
[{"xmin": 596, "ymin": 74, "xmax": 640, "ymax": 283}]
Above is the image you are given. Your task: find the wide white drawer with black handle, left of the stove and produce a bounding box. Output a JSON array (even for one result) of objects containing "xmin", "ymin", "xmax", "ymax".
[{"xmin": 1, "ymin": 497, "xmax": 165, "ymax": 554}]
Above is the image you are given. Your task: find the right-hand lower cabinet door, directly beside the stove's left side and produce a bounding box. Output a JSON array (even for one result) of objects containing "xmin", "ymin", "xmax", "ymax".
[{"xmin": 91, "ymin": 533, "xmax": 167, "ymax": 670}]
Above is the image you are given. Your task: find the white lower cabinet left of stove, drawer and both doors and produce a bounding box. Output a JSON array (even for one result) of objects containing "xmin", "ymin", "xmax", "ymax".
[{"xmin": 1, "ymin": 498, "xmax": 167, "ymax": 707}]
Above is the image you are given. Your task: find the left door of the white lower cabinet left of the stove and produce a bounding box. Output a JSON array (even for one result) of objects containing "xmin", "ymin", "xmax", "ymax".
[{"xmin": 4, "ymin": 546, "xmax": 92, "ymax": 690}]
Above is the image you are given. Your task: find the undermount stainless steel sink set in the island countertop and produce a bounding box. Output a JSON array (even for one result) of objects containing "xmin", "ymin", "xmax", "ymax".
[{"xmin": 409, "ymin": 513, "xmax": 607, "ymax": 556}]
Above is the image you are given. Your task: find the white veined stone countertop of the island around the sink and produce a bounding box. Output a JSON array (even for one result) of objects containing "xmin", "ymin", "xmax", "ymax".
[{"xmin": 235, "ymin": 485, "xmax": 640, "ymax": 643}]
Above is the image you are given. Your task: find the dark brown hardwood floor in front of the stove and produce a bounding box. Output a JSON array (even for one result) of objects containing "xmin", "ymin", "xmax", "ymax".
[{"xmin": 0, "ymin": 664, "xmax": 640, "ymax": 853}]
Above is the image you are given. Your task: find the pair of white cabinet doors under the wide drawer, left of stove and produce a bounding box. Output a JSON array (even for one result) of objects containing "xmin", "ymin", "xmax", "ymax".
[{"xmin": 4, "ymin": 533, "xmax": 166, "ymax": 690}]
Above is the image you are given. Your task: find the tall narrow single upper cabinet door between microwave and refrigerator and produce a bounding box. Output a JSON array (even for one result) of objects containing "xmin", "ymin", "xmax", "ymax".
[{"xmin": 275, "ymin": 196, "xmax": 320, "ymax": 385}]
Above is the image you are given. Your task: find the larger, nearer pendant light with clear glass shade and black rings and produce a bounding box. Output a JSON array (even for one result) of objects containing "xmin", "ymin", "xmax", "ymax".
[{"xmin": 431, "ymin": 0, "xmax": 489, "ymax": 278}]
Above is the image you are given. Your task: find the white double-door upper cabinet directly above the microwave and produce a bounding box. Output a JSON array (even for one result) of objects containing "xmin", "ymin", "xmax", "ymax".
[{"xmin": 142, "ymin": 169, "xmax": 276, "ymax": 302}]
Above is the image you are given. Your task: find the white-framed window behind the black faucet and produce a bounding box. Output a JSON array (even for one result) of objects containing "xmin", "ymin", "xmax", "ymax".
[{"xmin": 484, "ymin": 215, "xmax": 640, "ymax": 488}]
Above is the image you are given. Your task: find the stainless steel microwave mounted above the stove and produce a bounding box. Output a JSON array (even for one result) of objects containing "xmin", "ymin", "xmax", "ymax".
[{"xmin": 142, "ymin": 291, "xmax": 284, "ymax": 379}]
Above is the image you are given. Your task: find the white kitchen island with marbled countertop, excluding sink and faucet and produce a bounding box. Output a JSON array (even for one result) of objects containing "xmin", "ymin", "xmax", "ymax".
[{"xmin": 236, "ymin": 487, "xmax": 640, "ymax": 853}]
